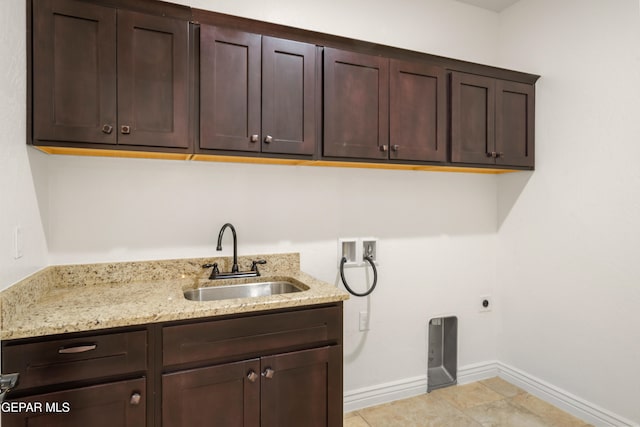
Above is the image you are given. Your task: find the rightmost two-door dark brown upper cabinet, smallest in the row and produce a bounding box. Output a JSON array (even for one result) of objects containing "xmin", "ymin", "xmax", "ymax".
[{"xmin": 451, "ymin": 72, "xmax": 534, "ymax": 169}]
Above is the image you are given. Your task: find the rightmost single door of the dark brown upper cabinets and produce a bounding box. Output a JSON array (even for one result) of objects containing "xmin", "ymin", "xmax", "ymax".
[{"xmin": 496, "ymin": 81, "xmax": 535, "ymax": 167}]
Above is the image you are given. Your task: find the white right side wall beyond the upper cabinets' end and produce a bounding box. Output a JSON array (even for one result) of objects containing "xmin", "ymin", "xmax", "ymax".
[{"xmin": 498, "ymin": 0, "xmax": 640, "ymax": 423}]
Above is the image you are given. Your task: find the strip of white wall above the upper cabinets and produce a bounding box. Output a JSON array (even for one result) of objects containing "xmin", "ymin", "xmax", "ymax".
[{"xmin": 185, "ymin": 0, "xmax": 498, "ymax": 64}]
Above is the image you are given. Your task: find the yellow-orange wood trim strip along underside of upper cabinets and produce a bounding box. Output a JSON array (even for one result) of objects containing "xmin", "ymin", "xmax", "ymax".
[{"xmin": 34, "ymin": 146, "xmax": 520, "ymax": 174}]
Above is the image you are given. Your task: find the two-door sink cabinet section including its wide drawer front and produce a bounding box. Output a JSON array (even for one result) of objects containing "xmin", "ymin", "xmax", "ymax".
[{"xmin": 161, "ymin": 304, "xmax": 343, "ymax": 427}]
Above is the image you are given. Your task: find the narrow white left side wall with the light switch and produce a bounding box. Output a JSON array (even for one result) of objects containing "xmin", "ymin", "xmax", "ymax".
[{"xmin": 0, "ymin": 0, "xmax": 47, "ymax": 289}]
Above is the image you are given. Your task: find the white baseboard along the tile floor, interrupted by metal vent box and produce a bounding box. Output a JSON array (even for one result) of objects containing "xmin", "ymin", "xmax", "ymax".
[{"xmin": 344, "ymin": 360, "xmax": 640, "ymax": 427}]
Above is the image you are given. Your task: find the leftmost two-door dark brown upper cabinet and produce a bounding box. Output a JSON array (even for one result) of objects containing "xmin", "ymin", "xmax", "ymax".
[{"xmin": 32, "ymin": 0, "xmax": 189, "ymax": 149}]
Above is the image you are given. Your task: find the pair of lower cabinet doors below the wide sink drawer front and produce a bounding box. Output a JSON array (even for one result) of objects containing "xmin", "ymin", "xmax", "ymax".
[{"xmin": 162, "ymin": 346, "xmax": 342, "ymax": 427}]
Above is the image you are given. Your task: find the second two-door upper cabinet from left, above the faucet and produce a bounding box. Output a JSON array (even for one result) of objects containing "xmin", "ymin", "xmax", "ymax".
[{"xmin": 200, "ymin": 25, "xmax": 316, "ymax": 155}]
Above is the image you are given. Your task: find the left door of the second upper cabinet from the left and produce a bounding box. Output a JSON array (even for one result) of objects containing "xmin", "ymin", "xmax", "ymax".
[{"xmin": 200, "ymin": 25, "xmax": 261, "ymax": 151}]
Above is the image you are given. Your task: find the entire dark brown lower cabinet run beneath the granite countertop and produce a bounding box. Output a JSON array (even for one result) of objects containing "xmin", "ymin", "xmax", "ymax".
[{"xmin": 2, "ymin": 303, "xmax": 342, "ymax": 427}]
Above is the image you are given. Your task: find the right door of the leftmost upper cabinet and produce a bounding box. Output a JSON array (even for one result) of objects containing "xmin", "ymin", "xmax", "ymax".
[{"xmin": 117, "ymin": 10, "xmax": 189, "ymax": 148}]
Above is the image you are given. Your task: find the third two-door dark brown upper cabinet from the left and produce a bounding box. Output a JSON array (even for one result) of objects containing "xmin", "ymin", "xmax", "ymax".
[{"xmin": 323, "ymin": 49, "xmax": 447, "ymax": 162}]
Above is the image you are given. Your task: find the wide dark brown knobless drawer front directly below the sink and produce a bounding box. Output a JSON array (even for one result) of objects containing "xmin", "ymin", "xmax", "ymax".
[{"xmin": 162, "ymin": 306, "xmax": 342, "ymax": 366}]
